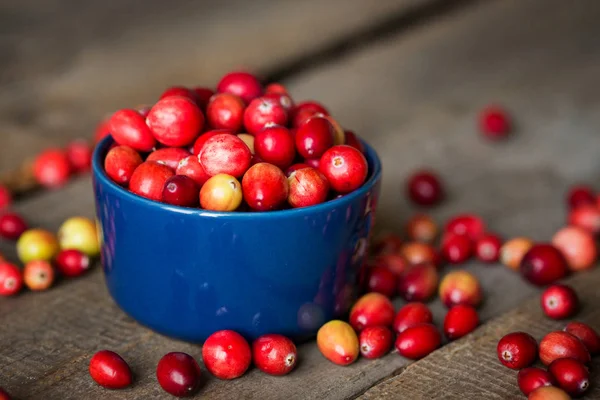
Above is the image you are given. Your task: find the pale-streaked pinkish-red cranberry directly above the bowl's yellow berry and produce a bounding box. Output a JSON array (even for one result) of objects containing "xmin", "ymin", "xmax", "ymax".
[{"xmin": 198, "ymin": 133, "xmax": 252, "ymax": 178}]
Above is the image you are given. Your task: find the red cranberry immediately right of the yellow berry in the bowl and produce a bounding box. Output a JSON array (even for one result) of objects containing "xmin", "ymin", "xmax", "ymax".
[{"xmin": 242, "ymin": 163, "xmax": 289, "ymax": 211}]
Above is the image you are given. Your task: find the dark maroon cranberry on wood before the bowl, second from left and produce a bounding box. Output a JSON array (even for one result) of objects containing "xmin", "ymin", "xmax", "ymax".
[{"xmin": 156, "ymin": 352, "xmax": 201, "ymax": 397}]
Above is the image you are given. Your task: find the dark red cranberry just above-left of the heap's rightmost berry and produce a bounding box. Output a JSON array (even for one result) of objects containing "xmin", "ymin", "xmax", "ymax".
[{"xmin": 295, "ymin": 117, "xmax": 334, "ymax": 158}]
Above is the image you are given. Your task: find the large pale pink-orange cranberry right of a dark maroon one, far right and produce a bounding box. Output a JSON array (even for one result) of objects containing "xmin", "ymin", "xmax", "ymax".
[{"xmin": 552, "ymin": 226, "xmax": 598, "ymax": 271}]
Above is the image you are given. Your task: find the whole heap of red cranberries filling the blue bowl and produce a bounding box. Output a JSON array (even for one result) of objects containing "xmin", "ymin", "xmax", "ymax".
[{"xmin": 100, "ymin": 72, "xmax": 369, "ymax": 211}]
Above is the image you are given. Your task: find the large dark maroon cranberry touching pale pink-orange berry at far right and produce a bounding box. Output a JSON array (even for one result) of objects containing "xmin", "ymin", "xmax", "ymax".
[{"xmin": 520, "ymin": 244, "xmax": 568, "ymax": 286}]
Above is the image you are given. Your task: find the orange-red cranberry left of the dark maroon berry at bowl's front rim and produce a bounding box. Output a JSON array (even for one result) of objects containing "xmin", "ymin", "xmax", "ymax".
[{"xmin": 129, "ymin": 161, "xmax": 175, "ymax": 201}]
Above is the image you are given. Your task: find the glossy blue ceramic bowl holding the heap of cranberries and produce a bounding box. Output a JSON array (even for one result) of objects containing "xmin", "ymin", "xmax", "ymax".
[{"xmin": 93, "ymin": 137, "xmax": 381, "ymax": 342}]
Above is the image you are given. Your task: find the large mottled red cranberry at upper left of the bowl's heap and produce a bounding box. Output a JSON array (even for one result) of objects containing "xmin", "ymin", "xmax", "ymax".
[{"xmin": 146, "ymin": 96, "xmax": 204, "ymax": 147}]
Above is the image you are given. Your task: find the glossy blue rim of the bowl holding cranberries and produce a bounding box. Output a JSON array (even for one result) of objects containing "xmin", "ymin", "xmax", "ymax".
[{"xmin": 92, "ymin": 135, "xmax": 382, "ymax": 219}]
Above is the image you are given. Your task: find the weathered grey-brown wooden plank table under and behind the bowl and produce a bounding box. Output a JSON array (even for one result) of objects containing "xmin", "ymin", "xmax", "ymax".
[{"xmin": 0, "ymin": 0, "xmax": 600, "ymax": 400}]
